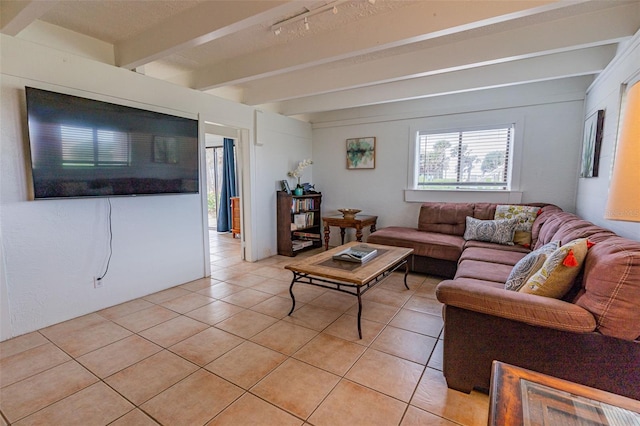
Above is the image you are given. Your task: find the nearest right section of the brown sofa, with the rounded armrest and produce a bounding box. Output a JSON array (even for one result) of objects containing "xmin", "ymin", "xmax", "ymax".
[{"xmin": 436, "ymin": 210, "xmax": 640, "ymax": 399}]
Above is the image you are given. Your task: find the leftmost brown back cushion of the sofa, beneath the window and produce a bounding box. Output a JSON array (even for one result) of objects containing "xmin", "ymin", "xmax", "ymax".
[{"xmin": 418, "ymin": 203, "xmax": 473, "ymax": 236}]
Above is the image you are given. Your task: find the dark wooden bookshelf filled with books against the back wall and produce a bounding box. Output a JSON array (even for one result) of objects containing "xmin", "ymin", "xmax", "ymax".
[{"xmin": 276, "ymin": 191, "xmax": 322, "ymax": 256}]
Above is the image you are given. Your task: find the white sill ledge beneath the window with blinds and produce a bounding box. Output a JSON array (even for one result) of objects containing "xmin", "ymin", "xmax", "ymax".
[{"xmin": 404, "ymin": 189, "xmax": 522, "ymax": 204}]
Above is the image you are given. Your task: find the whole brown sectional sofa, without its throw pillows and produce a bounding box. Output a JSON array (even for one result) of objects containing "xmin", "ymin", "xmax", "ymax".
[{"xmin": 367, "ymin": 203, "xmax": 640, "ymax": 400}]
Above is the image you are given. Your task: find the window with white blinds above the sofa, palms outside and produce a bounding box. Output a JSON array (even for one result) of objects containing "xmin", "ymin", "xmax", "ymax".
[{"xmin": 417, "ymin": 124, "xmax": 515, "ymax": 190}]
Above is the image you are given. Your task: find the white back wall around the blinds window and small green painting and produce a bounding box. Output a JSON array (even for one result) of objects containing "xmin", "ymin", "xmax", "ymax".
[{"xmin": 313, "ymin": 77, "xmax": 592, "ymax": 244}]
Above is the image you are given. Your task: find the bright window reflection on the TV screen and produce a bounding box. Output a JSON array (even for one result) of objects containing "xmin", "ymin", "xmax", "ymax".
[{"xmin": 60, "ymin": 126, "xmax": 131, "ymax": 167}]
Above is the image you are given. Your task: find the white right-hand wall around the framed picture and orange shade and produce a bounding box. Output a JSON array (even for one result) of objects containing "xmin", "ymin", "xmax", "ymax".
[{"xmin": 577, "ymin": 32, "xmax": 640, "ymax": 241}]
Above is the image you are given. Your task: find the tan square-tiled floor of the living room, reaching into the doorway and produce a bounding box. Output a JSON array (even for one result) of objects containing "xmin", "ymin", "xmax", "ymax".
[{"xmin": 0, "ymin": 232, "xmax": 489, "ymax": 426}]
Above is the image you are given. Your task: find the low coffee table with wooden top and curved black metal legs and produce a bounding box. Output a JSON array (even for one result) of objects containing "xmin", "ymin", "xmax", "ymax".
[{"xmin": 285, "ymin": 241, "xmax": 413, "ymax": 339}]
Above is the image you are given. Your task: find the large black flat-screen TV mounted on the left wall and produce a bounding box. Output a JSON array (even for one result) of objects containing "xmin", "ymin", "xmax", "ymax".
[{"xmin": 25, "ymin": 87, "xmax": 199, "ymax": 199}]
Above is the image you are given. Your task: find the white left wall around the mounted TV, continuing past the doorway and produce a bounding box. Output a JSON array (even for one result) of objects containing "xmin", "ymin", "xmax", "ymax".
[{"xmin": 0, "ymin": 35, "xmax": 311, "ymax": 340}]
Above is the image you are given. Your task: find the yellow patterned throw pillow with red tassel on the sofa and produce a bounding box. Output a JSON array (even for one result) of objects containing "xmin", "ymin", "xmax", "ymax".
[{"xmin": 519, "ymin": 238, "xmax": 589, "ymax": 299}]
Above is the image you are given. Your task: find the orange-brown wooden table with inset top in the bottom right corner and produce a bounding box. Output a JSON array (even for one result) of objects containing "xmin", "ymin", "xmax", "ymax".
[{"xmin": 488, "ymin": 361, "xmax": 640, "ymax": 426}]
